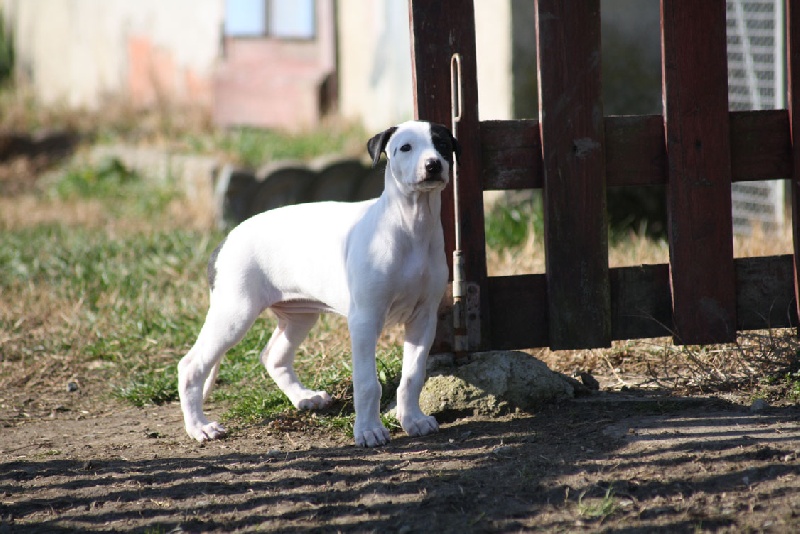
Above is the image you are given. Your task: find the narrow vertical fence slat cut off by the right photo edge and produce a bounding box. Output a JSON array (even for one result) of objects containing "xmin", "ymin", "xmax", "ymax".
[{"xmin": 786, "ymin": 0, "xmax": 800, "ymax": 333}]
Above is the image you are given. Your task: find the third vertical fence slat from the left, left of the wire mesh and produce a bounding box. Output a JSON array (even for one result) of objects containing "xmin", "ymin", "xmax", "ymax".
[{"xmin": 661, "ymin": 0, "xmax": 736, "ymax": 344}]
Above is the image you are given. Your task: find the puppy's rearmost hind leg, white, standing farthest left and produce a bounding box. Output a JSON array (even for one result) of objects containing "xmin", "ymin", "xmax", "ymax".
[{"xmin": 178, "ymin": 302, "xmax": 261, "ymax": 442}]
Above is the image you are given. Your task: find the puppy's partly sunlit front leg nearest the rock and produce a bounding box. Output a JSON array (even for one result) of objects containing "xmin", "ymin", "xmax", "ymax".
[{"xmin": 397, "ymin": 308, "xmax": 439, "ymax": 436}]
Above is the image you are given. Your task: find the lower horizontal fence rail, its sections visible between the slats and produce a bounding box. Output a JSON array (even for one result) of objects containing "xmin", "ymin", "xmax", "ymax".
[{"xmin": 486, "ymin": 254, "xmax": 798, "ymax": 350}]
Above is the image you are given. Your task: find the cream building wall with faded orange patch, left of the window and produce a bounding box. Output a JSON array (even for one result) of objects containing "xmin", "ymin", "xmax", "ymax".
[{"xmin": 3, "ymin": 0, "xmax": 224, "ymax": 108}]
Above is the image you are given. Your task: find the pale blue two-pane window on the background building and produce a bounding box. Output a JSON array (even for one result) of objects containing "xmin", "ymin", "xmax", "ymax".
[{"xmin": 225, "ymin": 0, "xmax": 316, "ymax": 39}]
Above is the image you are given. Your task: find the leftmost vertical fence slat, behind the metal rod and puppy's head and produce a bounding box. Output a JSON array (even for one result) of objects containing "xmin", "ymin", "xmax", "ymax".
[{"xmin": 409, "ymin": 0, "xmax": 489, "ymax": 349}]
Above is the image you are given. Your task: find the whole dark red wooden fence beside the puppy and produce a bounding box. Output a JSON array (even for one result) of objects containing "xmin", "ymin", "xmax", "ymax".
[{"xmin": 410, "ymin": 0, "xmax": 800, "ymax": 350}]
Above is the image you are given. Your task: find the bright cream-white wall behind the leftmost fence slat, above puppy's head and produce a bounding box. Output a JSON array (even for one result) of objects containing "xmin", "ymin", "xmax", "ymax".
[{"xmin": 338, "ymin": 0, "xmax": 512, "ymax": 131}]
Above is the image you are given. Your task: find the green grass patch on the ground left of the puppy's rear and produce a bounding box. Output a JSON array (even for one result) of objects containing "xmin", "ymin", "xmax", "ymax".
[{"xmin": 0, "ymin": 221, "xmax": 214, "ymax": 390}]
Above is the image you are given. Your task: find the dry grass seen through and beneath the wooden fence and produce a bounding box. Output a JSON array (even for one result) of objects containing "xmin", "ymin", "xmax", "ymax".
[{"xmin": 487, "ymin": 213, "xmax": 800, "ymax": 402}]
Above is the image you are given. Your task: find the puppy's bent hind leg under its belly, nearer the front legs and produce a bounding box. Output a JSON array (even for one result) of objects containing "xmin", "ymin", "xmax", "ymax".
[{"xmin": 261, "ymin": 312, "xmax": 332, "ymax": 410}]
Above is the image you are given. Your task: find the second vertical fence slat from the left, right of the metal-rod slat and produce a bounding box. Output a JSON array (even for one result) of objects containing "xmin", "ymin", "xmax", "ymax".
[{"xmin": 536, "ymin": 0, "xmax": 611, "ymax": 349}]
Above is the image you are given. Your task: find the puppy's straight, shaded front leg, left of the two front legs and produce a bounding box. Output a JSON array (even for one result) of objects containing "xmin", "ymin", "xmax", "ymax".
[{"xmin": 347, "ymin": 312, "xmax": 389, "ymax": 447}]
